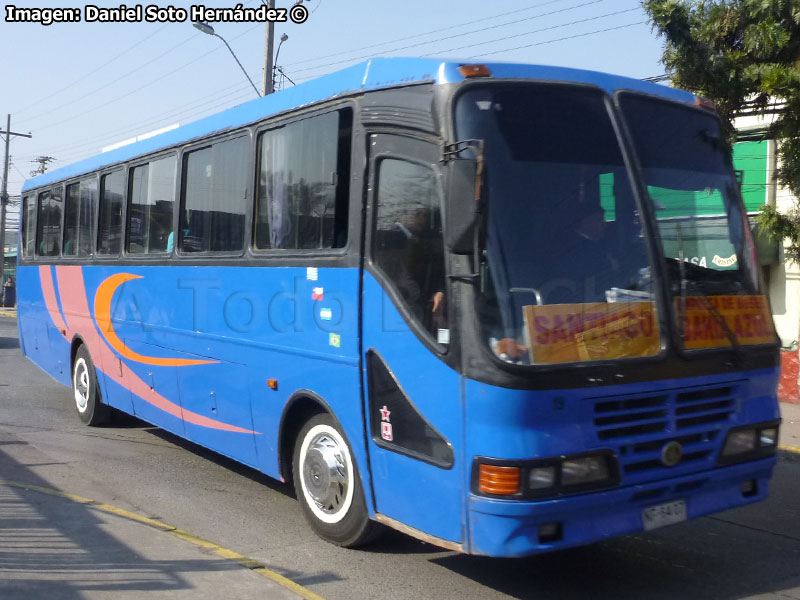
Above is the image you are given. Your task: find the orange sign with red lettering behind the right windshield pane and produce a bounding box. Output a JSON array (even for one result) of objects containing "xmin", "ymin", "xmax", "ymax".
[{"xmin": 675, "ymin": 296, "xmax": 775, "ymax": 350}]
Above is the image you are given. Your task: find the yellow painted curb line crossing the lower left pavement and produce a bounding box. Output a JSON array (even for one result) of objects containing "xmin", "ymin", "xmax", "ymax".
[{"xmin": 0, "ymin": 479, "xmax": 324, "ymax": 600}]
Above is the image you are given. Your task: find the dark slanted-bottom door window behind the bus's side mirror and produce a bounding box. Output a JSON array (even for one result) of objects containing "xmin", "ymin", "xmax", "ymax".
[{"xmin": 373, "ymin": 158, "xmax": 448, "ymax": 343}]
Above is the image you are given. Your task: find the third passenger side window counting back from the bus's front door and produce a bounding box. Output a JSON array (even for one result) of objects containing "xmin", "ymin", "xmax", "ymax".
[{"xmin": 128, "ymin": 156, "xmax": 177, "ymax": 254}]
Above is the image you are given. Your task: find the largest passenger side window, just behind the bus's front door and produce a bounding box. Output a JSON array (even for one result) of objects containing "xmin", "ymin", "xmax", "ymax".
[{"xmin": 255, "ymin": 109, "xmax": 352, "ymax": 249}]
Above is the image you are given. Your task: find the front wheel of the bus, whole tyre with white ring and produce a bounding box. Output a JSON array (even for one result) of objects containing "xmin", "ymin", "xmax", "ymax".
[{"xmin": 292, "ymin": 414, "xmax": 380, "ymax": 548}]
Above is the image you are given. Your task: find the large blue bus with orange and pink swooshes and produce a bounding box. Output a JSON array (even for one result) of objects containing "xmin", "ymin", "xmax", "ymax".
[{"xmin": 17, "ymin": 58, "xmax": 780, "ymax": 557}]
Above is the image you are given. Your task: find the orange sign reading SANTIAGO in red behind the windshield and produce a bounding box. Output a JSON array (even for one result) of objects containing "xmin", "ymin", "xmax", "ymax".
[{"xmin": 523, "ymin": 302, "xmax": 661, "ymax": 364}]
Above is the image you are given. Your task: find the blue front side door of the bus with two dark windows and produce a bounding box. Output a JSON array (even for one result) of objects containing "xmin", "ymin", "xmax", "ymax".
[{"xmin": 362, "ymin": 134, "xmax": 465, "ymax": 546}]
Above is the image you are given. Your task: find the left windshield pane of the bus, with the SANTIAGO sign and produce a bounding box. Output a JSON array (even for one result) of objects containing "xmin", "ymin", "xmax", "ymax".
[{"xmin": 456, "ymin": 84, "xmax": 660, "ymax": 364}]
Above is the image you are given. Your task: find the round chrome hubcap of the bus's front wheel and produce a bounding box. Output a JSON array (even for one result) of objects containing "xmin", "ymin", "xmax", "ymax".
[{"xmin": 303, "ymin": 433, "xmax": 350, "ymax": 514}]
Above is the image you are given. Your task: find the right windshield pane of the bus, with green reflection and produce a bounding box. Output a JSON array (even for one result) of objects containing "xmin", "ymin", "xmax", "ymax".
[{"xmin": 621, "ymin": 95, "xmax": 775, "ymax": 349}]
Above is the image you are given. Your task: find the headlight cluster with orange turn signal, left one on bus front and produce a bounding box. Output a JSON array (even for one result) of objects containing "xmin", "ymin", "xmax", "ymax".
[{"xmin": 472, "ymin": 450, "xmax": 619, "ymax": 499}]
